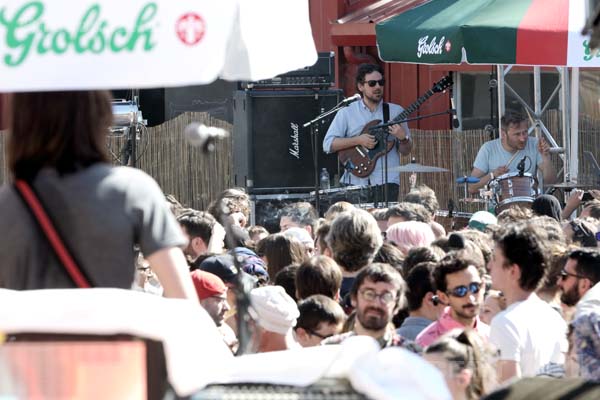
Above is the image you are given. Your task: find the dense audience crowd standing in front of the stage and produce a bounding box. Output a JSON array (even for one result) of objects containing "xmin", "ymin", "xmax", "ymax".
[{"xmin": 161, "ymin": 180, "xmax": 600, "ymax": 398}]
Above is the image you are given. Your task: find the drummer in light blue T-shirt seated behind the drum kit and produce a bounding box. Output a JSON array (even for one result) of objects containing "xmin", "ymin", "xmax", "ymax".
[{"xmin": 469, "ymin": 109, "xmax": 557, "ymax": 193}]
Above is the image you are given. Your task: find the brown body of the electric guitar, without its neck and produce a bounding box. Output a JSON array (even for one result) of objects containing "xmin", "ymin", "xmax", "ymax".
[{"xmin": 338, "ymin": 119, "xmax": 394, "ymax": 178}]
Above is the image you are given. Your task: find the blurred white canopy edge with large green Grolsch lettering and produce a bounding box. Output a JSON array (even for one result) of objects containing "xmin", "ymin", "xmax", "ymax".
[{"xmin": 0, "ymin": 0, "xmax": 317, "ymax": 92}]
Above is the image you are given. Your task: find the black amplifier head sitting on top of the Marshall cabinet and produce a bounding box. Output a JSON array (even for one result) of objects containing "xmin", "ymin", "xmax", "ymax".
[{"xmin": 241, "ymin": 52, "xmax": 335, "ymax": 89}]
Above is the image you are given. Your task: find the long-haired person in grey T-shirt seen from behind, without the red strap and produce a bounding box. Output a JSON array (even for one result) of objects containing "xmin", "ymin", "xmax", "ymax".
[{"xmin": 0, "ymin": 91, "xmax": 197, "ymax": 299}]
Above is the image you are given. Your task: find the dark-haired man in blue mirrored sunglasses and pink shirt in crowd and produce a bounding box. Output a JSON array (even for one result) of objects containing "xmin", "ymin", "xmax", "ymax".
[{"xmin": 417, "ymin": 255, "xmax": 490, "ymax": 347}]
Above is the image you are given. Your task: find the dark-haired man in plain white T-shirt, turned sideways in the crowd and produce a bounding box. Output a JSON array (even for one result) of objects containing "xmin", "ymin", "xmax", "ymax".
[{"xmin": 488, "ymin": 222, "xmax": 567, "ymax": 382}]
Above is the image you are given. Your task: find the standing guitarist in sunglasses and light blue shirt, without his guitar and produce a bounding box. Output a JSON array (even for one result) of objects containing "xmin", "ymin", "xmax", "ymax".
[{"xmin": 323, "ymin": 64, "xmax": 412, "ymax": 201}]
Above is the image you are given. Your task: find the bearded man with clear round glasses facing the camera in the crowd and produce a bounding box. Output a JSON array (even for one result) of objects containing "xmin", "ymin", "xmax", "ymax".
[{"xmin": 322, "ymin": 263, "xmax": 419, "ymax": 351}]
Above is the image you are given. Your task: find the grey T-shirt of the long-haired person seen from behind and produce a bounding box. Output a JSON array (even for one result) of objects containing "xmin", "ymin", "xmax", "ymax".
[{"xmin": 0, "ymin": 164, "xmax": 186, "ymax": 289}]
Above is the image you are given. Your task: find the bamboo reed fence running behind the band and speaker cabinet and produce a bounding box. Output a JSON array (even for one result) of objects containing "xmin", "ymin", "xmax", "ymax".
[{"xmin": 0, "ymin": 110, "xmax": 600, "ymax": 216}]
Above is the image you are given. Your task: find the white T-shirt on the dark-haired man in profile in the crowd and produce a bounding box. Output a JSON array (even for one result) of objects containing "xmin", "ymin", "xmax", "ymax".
[{"xmin": 490, "ymin": 293, "xmax": 568, "ymax": 376}]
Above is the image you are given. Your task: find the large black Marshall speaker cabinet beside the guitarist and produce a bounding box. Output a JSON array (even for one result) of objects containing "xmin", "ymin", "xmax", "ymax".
[{"xmin": 233, "ymin": 90, "xmax": 342, "ymax": 193}]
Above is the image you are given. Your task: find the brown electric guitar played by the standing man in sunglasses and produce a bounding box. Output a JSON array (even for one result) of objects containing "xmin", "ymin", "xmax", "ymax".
[{"xmin": 338, "ymin": 75, "xmax": 453, "ymax": 178}]
